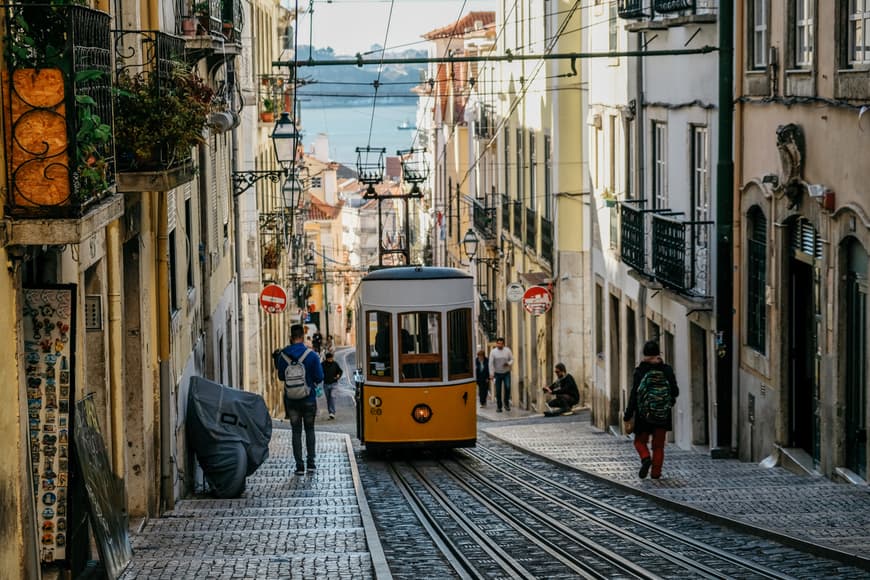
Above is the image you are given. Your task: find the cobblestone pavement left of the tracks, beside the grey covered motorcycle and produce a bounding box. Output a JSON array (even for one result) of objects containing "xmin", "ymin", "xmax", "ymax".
[{"xmin": 122, "ymin": 428, "xmax": 389, "ymax": 580}]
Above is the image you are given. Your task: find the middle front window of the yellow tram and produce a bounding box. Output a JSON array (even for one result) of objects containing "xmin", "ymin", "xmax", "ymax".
[{"xmin": 399, "ymin": 312, "xmax": 441, "ymax": 381}]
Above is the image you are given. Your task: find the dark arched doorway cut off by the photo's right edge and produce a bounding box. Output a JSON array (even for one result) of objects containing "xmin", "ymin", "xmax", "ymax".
[{"xmin": 843, "ymin": 240, "xmax": 870, "ymax": 479}]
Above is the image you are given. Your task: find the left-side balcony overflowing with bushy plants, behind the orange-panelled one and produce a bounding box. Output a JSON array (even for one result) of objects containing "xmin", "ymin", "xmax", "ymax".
[{"xmin": 113, "ymin": 30, "xmax": 197, "ymax": 192}]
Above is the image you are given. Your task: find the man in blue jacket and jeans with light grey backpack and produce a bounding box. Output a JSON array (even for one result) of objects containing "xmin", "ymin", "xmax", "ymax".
[{"xmin": 272, "ymin": 324, "xmax": 323, "ymax": 475}]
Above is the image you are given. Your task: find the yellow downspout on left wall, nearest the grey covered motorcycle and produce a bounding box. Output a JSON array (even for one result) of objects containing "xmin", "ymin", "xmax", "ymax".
[{"xmin": 106, "ymin": 220, "xmax": 127, "ymax": 480}]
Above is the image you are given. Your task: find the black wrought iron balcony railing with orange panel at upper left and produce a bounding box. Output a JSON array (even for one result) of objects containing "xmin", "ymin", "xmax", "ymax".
[{"xmin": 2, "ymin": 4, "xmax": 115, "ymax": 218}]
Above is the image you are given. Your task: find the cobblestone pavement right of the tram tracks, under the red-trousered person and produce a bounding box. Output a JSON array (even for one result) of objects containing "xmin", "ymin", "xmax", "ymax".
[{"xmin": 480, "ymin": 408, "xmax": 870, "ymax": 569}]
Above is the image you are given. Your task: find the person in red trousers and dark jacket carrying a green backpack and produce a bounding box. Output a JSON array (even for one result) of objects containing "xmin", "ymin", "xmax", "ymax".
[{"xmin": 622, "ymin": 340, "xmax": 680, "ymax": 479}]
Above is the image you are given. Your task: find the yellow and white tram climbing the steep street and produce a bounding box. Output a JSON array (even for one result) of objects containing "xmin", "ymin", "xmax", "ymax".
[{"xmin": 354, "ymin": 266, "xmax": 477, "ymax": 451}]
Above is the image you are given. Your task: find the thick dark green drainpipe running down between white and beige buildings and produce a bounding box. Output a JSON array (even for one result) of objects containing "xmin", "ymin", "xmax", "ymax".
[{"xmin": 712, "ymin": 0, "xmax": 734, "ymax": 456}]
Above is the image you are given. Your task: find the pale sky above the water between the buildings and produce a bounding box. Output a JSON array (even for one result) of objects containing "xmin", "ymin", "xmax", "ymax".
[{"xmin": 292, "ymin": 0, "xmax": 496, "ymax": 55}]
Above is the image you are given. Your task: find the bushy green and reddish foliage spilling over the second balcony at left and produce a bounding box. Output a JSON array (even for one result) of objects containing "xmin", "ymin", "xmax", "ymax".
[{"xmin": 115, "ymin": 63, "xmax": 214, "ymax": 170}]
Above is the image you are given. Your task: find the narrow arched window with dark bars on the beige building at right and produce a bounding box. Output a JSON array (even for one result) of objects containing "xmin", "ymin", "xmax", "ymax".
[{"xmin": 746, "ymin": 206, "xmax": 767, "ymax": 354}]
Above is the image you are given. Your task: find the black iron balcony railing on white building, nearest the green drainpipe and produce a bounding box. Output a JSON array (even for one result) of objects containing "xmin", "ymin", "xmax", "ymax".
[{"xmin": 652, "ymin": 214, "xmax": 713, "ymax": 296}]
